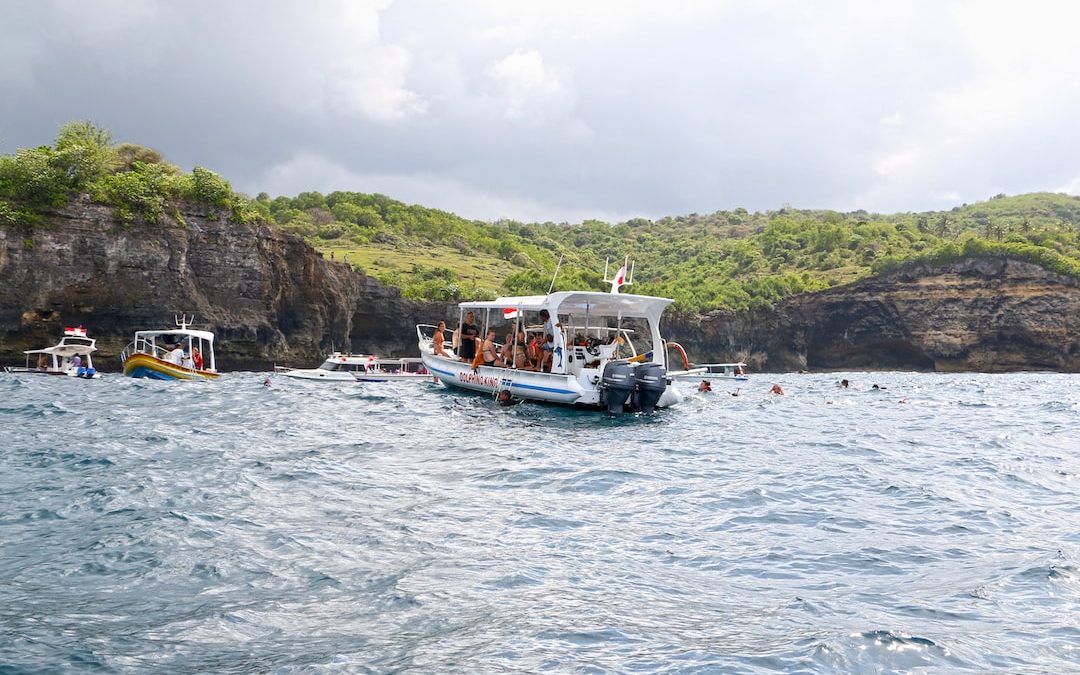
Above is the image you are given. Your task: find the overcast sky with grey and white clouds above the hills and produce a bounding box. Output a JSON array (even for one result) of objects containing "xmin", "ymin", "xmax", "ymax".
[{"xmin": 0, "ymin": 0, "xmax": 1080, "ymax": 221}]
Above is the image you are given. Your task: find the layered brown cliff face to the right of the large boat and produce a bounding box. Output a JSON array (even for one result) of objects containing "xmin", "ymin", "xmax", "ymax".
[{"xmin": 666, "ymin": 257, "xmax": 1080, "ymax": 373}]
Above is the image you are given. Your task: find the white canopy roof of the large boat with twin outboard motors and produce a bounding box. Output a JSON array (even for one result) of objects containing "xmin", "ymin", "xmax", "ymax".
[{"xmin": 461, "ymin": 291, "xmax": 675, "ymax": 321}]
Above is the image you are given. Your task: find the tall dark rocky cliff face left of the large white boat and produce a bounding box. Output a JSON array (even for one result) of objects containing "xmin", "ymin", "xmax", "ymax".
[{"xmin": 0, "ymin": 198, "xmax": 449, "ymax": 369}]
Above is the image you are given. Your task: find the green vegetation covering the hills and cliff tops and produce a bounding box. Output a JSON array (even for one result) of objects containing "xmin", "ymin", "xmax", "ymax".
[{"xmin": 0, "ymin": 122, "xmax": 1080, "ymax": 311}]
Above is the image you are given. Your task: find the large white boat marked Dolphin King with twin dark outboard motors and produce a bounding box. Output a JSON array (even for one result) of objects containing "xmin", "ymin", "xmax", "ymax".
[{"xmin": 417, "ymin": 260, "xmax": 683, "ymax": 413}]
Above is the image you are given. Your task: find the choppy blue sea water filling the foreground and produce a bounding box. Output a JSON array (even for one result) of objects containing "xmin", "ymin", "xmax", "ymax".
[{"xmin": 0, "ymin": 373, "xmax": 1080, "ymax": 673}]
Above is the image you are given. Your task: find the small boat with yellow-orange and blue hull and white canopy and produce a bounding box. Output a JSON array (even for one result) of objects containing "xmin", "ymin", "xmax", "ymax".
[{"xmin": 120, "ymin": 314, "xmax": 220, "ymax": 380}]
